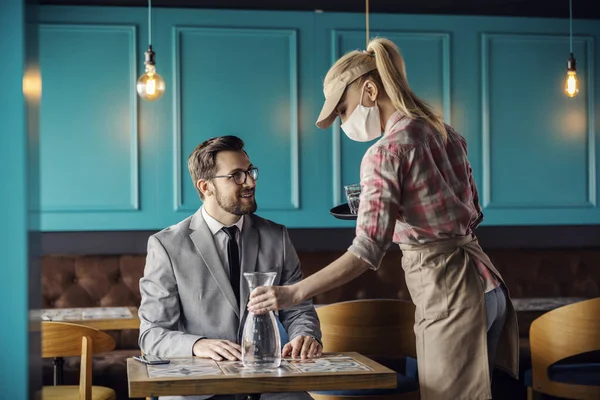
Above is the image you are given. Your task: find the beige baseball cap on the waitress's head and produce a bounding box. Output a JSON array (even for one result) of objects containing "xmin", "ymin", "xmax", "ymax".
[{"xmin": 316, "ymin": 62, "xmax": 377, "ymax": 129}]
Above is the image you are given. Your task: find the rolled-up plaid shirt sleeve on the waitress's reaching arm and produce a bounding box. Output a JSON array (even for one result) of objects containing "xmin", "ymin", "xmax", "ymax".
[{"xmin": 348, "ymin": 146, "xmax": 402, "ymax": 270}]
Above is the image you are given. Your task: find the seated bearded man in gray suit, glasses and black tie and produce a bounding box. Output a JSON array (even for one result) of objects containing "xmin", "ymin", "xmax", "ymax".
[{"xmin": 139, "ymin": 136, "xmax": 322, "ymax": 400}]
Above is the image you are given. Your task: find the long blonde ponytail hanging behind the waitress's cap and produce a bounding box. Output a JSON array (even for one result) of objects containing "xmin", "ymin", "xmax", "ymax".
[{"xmin": 362, "ymin": 38, "xmax": 448, "ymax": 141}]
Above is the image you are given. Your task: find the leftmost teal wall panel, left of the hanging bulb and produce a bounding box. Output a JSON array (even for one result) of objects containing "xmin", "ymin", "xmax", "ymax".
[{"xmin": 40, "ymin": 24, "xmax": 140, "ymax": 213}]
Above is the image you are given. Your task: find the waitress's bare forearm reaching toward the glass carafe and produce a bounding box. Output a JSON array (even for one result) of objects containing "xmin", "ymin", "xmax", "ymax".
[{"xmin": 294, "ymin": 251, "xmax": 370, "ymax": 302}]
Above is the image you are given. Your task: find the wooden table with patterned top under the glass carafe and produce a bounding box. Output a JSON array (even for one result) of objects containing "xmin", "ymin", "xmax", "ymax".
[{"xmin": 127, "ymin": 352, "xmax": 397, "ymax": 397}]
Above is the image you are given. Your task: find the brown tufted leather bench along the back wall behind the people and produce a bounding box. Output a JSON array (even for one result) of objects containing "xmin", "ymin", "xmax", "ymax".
[{"xmin": 42, "ymin": 249, "xmax": 600, "ymax": 399}]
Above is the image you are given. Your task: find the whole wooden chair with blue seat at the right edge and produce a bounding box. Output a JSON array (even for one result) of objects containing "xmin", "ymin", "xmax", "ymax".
[{"xmin": 527, "ymin": 298, "xmax": 600, "ymax": 400}]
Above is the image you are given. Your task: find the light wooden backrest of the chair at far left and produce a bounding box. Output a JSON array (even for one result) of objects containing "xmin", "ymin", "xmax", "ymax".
[{"xmin": 42, "ymin": 321, "xmax": 115, "ymax": 400}]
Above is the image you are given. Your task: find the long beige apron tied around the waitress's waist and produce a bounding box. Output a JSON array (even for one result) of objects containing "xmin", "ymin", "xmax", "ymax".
[{"xmin": 400, "ymin": 235, "xmax": 519, "ymax": 400}]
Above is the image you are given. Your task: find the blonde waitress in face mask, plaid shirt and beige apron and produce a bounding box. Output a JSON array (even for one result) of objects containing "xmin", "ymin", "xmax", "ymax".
[{"xmin": 248, "ymin": 38, "xmax": 518, "ymax": 400}]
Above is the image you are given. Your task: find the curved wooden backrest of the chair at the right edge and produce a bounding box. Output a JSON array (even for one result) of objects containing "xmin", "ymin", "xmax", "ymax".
[{"xmin": 529, "ymin": 297, "xmax": 600, "ymax": 399}]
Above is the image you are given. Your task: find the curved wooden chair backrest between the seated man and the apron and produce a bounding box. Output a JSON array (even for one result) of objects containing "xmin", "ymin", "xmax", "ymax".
[{"xmin": 317, "ymin": 299, "xmax": 417, "ymax": 357}]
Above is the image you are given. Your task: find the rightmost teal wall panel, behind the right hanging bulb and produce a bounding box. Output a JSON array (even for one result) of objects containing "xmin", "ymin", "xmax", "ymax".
[{"xmin": 481, "ymin": 34, "xmax": 596, "ymax": 212}]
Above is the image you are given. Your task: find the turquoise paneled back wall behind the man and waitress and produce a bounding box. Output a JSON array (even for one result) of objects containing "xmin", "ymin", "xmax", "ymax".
[{"xmin": 40, "ymin": 6, "xmax": 600, "ymax": 231}]
